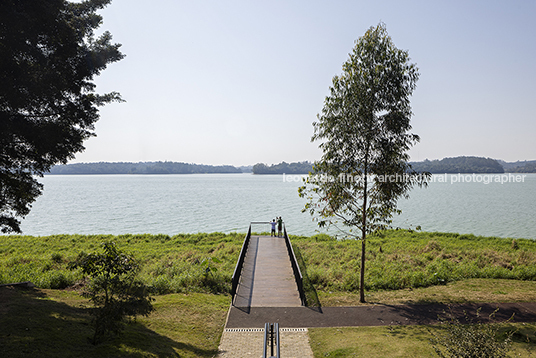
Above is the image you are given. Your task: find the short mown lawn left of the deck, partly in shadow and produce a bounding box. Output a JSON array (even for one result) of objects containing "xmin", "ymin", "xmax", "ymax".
[{"xmin": 0, "ymin": 287, "xmax": 230, "ymax": 358}]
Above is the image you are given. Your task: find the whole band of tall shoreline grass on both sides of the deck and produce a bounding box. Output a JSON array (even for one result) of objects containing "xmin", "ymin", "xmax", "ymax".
[{"xmin": 4, "ymin": 230, "xmax": 536, "ymax": 296}]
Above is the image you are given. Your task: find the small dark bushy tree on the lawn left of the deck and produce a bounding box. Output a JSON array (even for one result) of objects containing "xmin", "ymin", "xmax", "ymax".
[{"xmin": 69, "ymin": 242, "xmax": 154, "ymax": 344}]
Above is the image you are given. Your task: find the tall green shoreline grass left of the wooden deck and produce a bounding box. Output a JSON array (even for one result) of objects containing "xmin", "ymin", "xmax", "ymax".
[{"xmin": 0, "ymin": 233, "xmax": 244, "ymax": 294}]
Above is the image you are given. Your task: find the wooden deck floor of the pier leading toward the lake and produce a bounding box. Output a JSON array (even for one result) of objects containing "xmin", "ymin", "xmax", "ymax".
[{"xmin": 234, "ymin": 236, "xmax": 301, "ymax": 307}]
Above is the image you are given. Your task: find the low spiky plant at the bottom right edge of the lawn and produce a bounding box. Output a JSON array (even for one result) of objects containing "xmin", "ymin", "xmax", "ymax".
[{"xmin": 429, "ymin": 308, "xmax": 515, "ymax": 358}]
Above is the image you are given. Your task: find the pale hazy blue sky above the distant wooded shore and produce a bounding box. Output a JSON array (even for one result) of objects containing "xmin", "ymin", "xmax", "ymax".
[{"xmin": 71, "ymin": 0, "xmax": 536, "ymax": 166}]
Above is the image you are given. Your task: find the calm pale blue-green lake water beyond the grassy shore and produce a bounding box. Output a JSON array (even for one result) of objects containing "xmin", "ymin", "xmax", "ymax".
[{"xmin": 16, "ymin": 174, "xmax": 536, "ymax": 239}]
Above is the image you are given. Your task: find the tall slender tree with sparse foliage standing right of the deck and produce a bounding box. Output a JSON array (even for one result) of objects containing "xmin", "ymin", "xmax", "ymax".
[{"xmin": 299, "ymin": 23, "xmax": 428, "ymax": 302}]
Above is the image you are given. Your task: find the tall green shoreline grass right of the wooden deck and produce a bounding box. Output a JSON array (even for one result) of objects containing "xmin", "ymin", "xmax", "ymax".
[{"xmin": 291, "ymin": 230, "xmax": 536, "ymax": 292}]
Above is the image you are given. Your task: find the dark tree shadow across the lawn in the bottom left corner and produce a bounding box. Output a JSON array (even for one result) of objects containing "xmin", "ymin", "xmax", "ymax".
[{"xmin": 0, "ymin": 287, "xmax": 217, "ymax": 357}]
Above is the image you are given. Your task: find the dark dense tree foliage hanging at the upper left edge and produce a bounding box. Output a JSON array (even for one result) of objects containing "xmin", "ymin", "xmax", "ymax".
[{"xmin": 0, "ymin": 0, "xmax": 124, "ymax": 233}]
